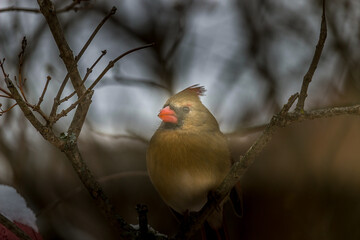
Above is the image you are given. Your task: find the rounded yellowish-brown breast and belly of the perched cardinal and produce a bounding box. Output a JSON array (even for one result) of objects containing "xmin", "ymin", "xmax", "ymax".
[{"xmin": 147, "ymin": 131, "xmax": 230, "ymax": 213}]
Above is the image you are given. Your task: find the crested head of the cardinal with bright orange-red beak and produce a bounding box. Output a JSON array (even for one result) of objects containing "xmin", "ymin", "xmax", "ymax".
[{"xmin": 158, "ymin": 85, "xmax": 219, "ymax": 131}]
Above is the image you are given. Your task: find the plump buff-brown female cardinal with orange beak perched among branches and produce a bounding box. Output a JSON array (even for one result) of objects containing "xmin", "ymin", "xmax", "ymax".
[{"xmin": 147, "ymin": 85, "xmax": 231, "ymax": 238}]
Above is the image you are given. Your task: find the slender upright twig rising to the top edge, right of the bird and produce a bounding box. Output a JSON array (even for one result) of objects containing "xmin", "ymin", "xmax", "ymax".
[{"xmin": 295, "ymin": 0, "xmax": 327, "ymax": 112}]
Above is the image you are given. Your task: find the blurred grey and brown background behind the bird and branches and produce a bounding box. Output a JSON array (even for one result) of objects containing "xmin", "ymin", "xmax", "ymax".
[{"xmin": 0, "ymin": 0, "xmax": 360, "ymax": 239}]
